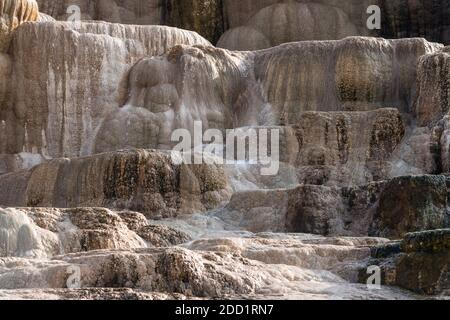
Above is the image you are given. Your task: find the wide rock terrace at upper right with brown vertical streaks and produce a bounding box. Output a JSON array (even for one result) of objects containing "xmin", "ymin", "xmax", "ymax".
[{"xmin": 254, "ymin": 37, "xmax": 442, "ymax": 124}]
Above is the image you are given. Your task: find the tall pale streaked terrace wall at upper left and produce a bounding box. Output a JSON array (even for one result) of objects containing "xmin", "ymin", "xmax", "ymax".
[{"xmin": 1, "ymin": 22, "xmax": 208, "ymax": 157}]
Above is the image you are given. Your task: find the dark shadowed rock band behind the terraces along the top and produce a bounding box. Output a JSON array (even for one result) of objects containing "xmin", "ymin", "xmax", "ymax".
[{"xmin": 37, "ymin": 0, "xmax": 450, "ymax": 46}]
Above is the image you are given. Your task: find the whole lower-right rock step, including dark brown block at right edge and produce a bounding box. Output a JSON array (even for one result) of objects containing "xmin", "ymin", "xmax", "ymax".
[{"xmin": 220, "ymin": 176, "xmax": 450, "ymax": 239}]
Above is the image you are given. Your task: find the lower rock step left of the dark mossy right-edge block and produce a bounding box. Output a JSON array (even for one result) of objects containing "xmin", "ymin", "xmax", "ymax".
[{"xmin": 218, "ymin": 183, "xmax": 384, "ymax": 236}]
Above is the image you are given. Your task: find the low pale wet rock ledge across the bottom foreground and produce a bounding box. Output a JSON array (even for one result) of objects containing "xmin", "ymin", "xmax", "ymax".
[{"xmin": 0, "ymin": 228, "xmax": 413, "ymax": 299}]
